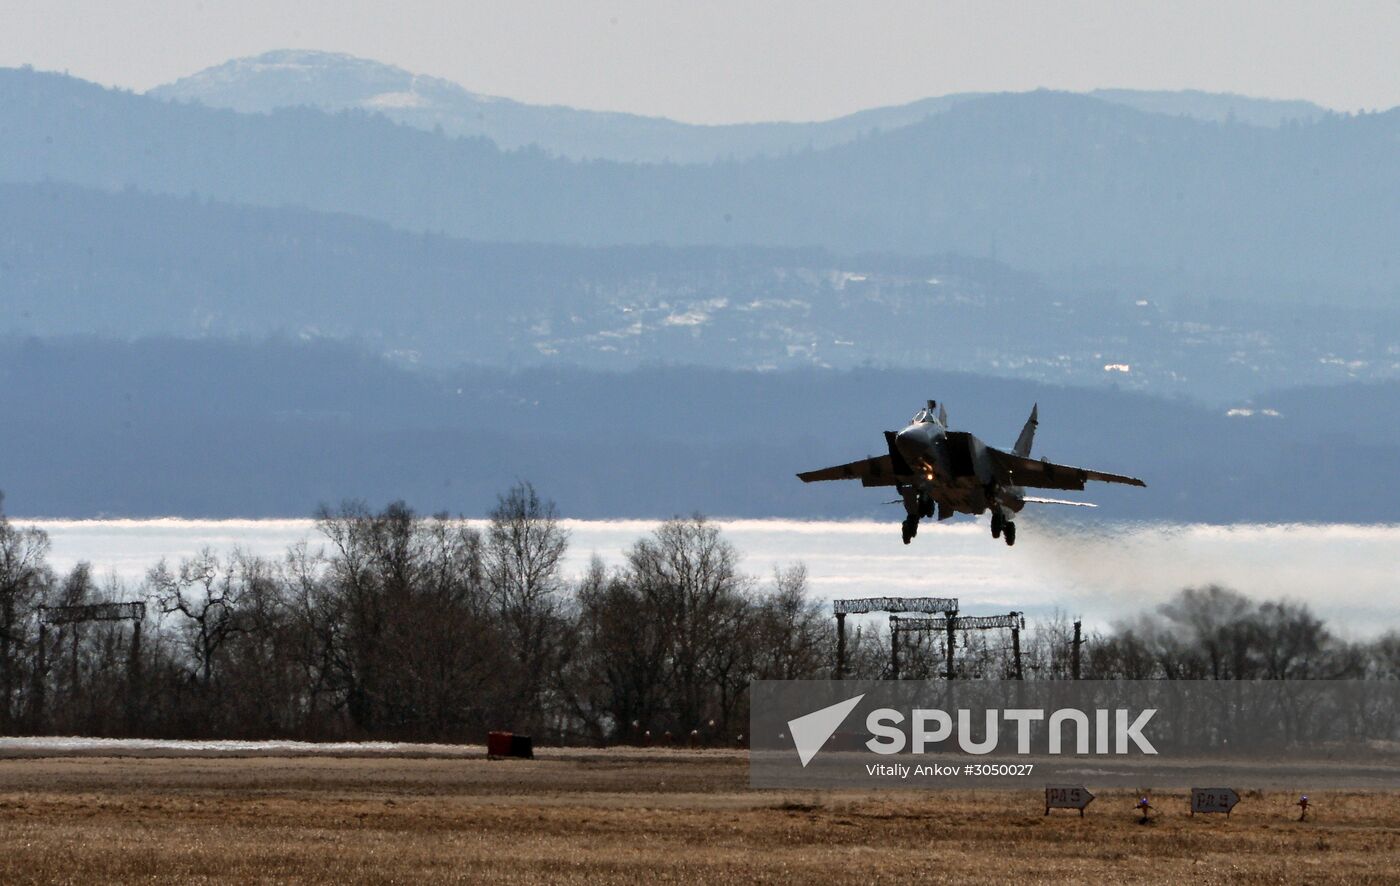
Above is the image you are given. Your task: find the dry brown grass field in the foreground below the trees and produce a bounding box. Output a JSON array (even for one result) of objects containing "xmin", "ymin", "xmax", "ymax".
[{"xmin": 0, "ymin": 750, "xmax": 1400, "ymax": 883}]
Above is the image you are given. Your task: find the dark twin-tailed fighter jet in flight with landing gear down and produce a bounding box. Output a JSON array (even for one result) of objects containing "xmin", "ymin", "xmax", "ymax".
[{"xmin": 798, "ymin": 400, "xmax": 1147, "ymax": 544}]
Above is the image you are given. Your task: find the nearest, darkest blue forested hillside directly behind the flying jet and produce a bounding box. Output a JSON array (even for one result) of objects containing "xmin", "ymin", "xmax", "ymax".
[{"xmin": 0, "ymin": 339, "xmax": 1400, "ymax": 522}]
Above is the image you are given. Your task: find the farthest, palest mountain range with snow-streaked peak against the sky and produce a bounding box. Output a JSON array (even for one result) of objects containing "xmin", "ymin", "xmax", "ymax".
[{"xmin": 147, "ymin": 49, "xmax": 1329, "ymax": 162}]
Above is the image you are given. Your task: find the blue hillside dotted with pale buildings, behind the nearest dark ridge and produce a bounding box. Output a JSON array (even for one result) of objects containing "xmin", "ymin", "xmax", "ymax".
[{"xmin": 0, "ymin": 183, "xmax": 1400, "ymax": 397}]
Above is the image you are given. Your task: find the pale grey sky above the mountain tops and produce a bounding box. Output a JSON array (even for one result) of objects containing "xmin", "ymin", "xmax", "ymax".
[{"xmin": 0, "ymin": 0, "xmax": 1400, "ymax": 123}]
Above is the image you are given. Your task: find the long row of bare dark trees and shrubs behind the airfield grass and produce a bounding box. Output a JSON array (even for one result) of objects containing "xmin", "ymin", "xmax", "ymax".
[{"xmin": 0, "ymin": 483, "xmax": 1400, "ymax": 743}]
